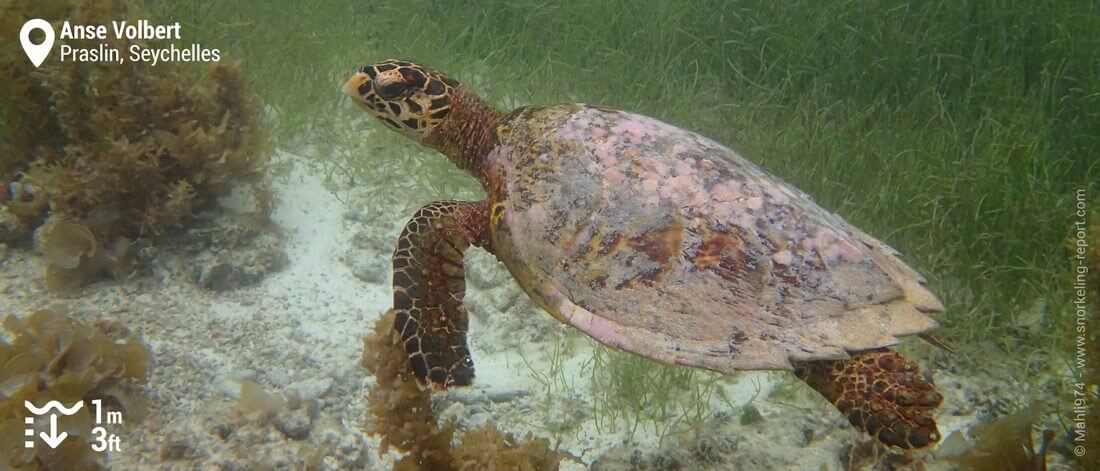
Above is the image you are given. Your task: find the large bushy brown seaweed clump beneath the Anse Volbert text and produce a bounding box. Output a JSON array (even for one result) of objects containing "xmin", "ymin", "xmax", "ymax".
[{"xmin": 0, "ymin": 0, "xmax": 271, "ymax": 292}]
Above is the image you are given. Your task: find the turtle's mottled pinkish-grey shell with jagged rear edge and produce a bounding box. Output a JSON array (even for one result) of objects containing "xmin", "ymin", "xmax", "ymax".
[{"xmin": 484, "ymin": 105, "xmax": 943, "ymax": 373}]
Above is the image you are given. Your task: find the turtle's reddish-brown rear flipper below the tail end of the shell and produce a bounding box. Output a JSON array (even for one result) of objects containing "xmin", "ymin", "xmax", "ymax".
[{"xmin": 794, "ymin": 348, "xmax": 944, "ymax": 449}]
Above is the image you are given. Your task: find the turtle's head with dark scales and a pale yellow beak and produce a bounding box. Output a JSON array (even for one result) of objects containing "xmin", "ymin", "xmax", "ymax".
[{"xmin": 342, "ymin": 59, "xmax": 459, "ymax": 141}]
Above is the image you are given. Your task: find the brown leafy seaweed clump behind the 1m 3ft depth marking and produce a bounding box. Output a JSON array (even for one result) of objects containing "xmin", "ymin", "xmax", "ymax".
[{"xmin": 0, "ymin": 310, "xmax": 150, "ymax": 470}]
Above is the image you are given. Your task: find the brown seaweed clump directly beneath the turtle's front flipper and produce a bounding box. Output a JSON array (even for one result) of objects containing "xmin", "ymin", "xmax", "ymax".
[{"xmin": 362, "ymin": 310, "xmax": 565, "ymax": 471}]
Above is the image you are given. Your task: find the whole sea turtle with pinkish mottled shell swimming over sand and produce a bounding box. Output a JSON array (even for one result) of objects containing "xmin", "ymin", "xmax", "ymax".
[{"xmin": 343, "ymin": 59, "xmax": 943, "ymax": 449}]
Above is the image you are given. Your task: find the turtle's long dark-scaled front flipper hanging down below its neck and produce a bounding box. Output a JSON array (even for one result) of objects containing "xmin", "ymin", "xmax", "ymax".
[{"xmin": 394, "ymin": 201, "xmax": 490, "ymax": 390}]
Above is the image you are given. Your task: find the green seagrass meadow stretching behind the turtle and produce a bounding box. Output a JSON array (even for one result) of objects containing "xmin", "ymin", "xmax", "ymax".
[{"xmin": 152, "ymin": 0, "xmax": 1100, "ymax": 376}]
